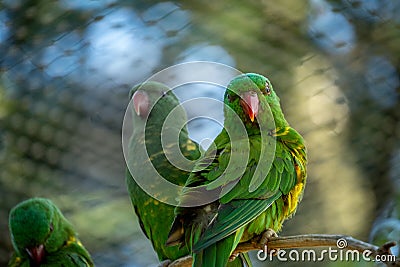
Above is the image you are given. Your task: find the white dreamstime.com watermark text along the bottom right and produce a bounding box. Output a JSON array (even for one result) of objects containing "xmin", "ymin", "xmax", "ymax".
[{"xmin": 257, "ymin": 238, "xmax": 396, "ymax": 262}]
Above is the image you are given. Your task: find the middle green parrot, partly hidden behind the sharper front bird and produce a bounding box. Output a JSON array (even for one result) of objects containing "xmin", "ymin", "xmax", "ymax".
[{"xmin": 126, "ymin": 82, "xmax": 201, "ymax": 261}]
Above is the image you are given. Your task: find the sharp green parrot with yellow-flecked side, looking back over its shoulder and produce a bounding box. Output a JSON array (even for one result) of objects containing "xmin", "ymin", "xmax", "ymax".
[{"xmin": 167, "ymin": 73, "xmax": 307, "ymax": 267}]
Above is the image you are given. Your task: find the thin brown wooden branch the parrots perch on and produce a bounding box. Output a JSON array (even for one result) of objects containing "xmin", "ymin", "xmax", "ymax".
[{"xmin": 168, "ymin": 234, "xmax": 400, "ymax": 267}]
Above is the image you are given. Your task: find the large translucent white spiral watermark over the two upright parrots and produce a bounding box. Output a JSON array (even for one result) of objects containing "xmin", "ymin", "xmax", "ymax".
[{"xmin": 122, "ymin": 61, "xmax": 275, "ymax": 207}]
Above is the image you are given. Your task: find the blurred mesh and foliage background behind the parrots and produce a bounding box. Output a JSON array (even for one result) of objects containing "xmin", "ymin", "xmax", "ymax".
[{"xmin": 0, "ymin": 0, "xmax": 400, "ymax": 266}]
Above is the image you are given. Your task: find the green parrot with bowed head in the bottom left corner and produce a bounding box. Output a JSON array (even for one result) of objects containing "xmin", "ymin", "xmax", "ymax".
[{"xmin": 8, "ymin": 198, "xmax": 94, "ymax": 267}]
